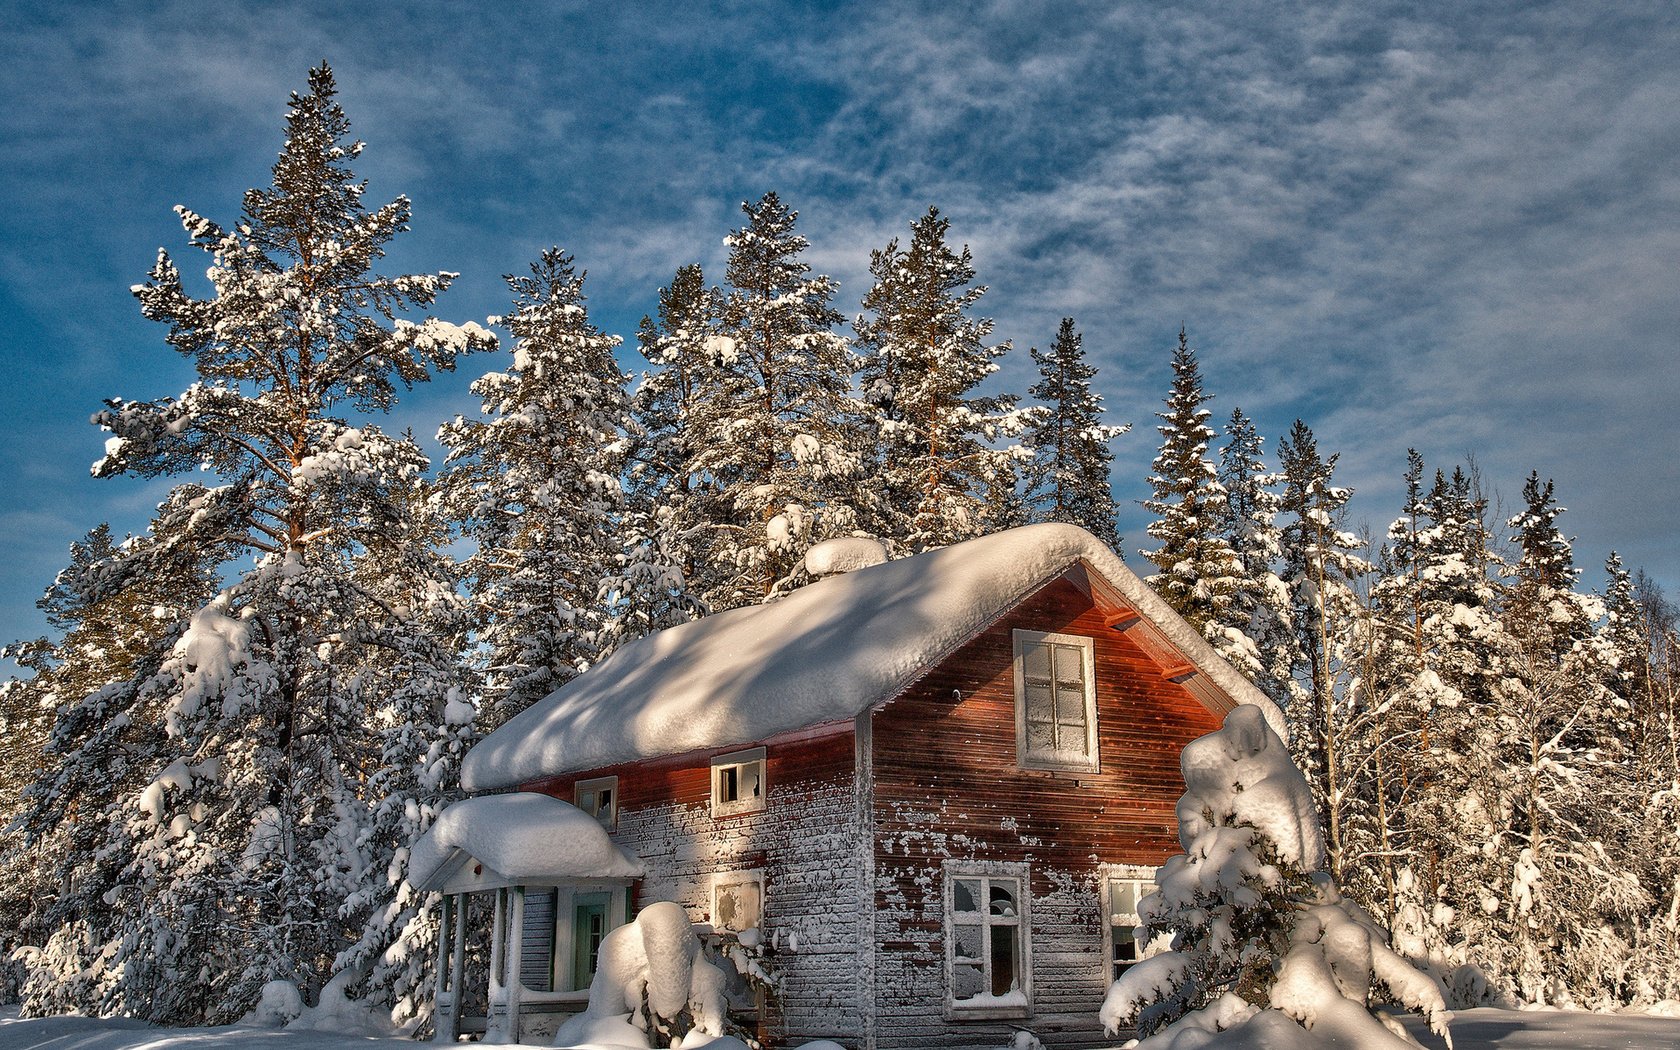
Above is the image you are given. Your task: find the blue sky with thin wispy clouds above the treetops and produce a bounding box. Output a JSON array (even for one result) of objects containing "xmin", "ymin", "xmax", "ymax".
[{"xmin": 0, "ymin": 2, "xmax": 1680, "ymax": 638}]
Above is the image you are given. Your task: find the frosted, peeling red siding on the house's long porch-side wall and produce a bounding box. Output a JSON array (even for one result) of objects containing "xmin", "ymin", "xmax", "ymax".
[{"xmin": 521, "ymin": 726, "xmax": 867, "ymax": 1045}]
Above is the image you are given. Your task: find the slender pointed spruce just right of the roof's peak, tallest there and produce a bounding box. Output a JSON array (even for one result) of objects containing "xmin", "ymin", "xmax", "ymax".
[{"xmin": 1142, "ymin": 328, "xmax": 1242, "ymax": 633}]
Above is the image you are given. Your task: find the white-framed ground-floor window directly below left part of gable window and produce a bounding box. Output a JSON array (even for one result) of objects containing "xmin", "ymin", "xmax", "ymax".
[{"xmin": 944, "ymin": 862, "xmax": 1032, "ymax": 1018}]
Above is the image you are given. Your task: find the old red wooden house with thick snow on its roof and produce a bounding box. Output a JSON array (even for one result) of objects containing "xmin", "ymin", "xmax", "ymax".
[{"xmin": 412, "ymin": 524, "xmax": 1282, "ymax": 1048}]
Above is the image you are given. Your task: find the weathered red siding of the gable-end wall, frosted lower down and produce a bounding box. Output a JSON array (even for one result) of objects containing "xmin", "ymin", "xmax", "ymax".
[{"xmin": 869, "ymin": 580, "xmax": 1220, "ymax": 1050}]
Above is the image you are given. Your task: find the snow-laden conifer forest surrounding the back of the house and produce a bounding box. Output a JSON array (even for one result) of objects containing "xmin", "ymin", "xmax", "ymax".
[{"xmin": 0, "ymin": 66, "xmax": 1680, "ymax": 1023}]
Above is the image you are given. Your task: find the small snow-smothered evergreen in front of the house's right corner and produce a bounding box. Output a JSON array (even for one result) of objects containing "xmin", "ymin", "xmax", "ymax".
[{"xmin": 1100, "ymin": 706, "xmax": 1452, "ymax": 1050}]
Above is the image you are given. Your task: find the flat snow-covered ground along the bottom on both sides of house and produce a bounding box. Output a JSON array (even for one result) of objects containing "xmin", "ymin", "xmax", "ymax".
[{"xmin": 0, "ymin": 1008, "xmax": 1680, "ymax": 1050}]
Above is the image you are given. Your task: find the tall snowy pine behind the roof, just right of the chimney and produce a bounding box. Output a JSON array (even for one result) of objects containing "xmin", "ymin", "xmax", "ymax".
[{"xmin": 853, "ymin": 208, "xmax": 1020, "ymax": 549}]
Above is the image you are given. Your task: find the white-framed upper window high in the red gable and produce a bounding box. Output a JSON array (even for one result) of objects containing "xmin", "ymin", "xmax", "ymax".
[{"xmin": 1015, "ymin": 630, "xmax": 1097, "ymax": 771}]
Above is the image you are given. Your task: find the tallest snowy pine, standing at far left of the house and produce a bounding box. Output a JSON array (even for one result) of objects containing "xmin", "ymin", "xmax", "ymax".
[{"xmin": 18, "ymin": 66, "xmax": 494, "ymax": 1021}]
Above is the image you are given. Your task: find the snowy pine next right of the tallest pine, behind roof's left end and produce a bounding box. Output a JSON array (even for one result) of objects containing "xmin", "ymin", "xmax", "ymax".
[{"xmin": 438, "ymin": 249, "xmax": 630, "ymax": 721}]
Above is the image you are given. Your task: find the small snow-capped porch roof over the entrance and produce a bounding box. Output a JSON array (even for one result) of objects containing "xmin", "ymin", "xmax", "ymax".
[{"xmin": 408, "ymin": 791, "xmax": 642, "ymax": 890}]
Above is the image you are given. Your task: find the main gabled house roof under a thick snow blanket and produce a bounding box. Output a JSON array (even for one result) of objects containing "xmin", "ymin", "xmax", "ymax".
[{"xmin": 462, "ymin": 524, "xmax": 1284, "ymax": 791}]
